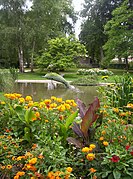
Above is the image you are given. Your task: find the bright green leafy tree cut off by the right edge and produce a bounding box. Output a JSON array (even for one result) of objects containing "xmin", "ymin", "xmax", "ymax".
[{"xmin": 104, "ymin": 0, "xmax": 133, "ymax": 69}]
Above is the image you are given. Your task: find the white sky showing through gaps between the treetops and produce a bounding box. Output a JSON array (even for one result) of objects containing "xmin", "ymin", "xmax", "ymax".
[{"xmin": 27, "ymin": 0, "xmax": 84, "ymax": 38}]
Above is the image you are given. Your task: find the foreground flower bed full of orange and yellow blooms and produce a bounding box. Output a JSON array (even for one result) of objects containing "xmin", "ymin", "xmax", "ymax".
[{"xmin": 0, "ymin": 74, "xmax": 133, "ymax": 179}]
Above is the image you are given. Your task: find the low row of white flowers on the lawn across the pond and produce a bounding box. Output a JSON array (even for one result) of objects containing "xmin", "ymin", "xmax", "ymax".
[{"xmin": 77, "ymin": 68, "xmax": 113, "ymax": 76}]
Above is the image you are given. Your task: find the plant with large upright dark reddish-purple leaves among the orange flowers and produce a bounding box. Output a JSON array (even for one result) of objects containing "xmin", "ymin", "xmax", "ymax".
[{"xmin": 67, "ymin": 97, "xmax": 101, "ymax": 148}]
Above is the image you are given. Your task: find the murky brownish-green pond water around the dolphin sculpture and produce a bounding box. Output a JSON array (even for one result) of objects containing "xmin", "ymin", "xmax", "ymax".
[{"xmin": 15, "ymin": 83, "xmax": 97, "ymax": 105}]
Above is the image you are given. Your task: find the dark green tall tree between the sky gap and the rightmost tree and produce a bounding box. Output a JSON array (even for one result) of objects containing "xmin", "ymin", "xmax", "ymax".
[{"xmin": 79, "ymin": 0, "xmax": 122, "ymax": 63}]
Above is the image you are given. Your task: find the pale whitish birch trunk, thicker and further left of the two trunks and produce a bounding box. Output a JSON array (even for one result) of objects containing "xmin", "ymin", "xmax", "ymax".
[{"xmin": 18, "ymin": 45, "xmax": 24, "ymax": 73}]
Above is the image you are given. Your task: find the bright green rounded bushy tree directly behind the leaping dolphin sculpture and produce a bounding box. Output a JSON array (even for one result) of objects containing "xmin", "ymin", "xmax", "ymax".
[{"xmin": 36, "ymin": 36, "xmax": 86, "ymax": 71}]
